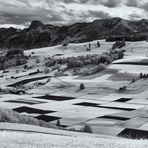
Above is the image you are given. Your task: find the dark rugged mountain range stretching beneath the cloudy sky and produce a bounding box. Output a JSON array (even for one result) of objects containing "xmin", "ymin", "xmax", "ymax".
[{"xmin": 0, "ymin": 18, "xmax": 148, "ymax": 49}]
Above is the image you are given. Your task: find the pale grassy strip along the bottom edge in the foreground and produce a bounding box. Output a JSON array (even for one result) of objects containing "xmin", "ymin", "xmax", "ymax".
[{"xmin": 0, "ymin": 131, "xmax": 148, "ymax": 148}]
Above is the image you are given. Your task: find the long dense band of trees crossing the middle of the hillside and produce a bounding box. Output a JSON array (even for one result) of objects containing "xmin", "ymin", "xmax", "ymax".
[{"xmin": 45, "ymin": 50, "xmax": 125, "ymax": 68}]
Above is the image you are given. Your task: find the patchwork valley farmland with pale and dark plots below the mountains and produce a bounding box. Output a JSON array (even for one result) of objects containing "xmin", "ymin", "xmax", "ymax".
[{"xmin": 0, "ymin": 40, "xmax": 148, "ymax": 138}]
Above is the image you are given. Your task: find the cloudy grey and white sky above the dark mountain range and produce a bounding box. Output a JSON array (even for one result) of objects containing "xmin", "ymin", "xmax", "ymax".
[{"xmin": 0, "ymin": 0, "xmax": 148, "ymax": 28}]
